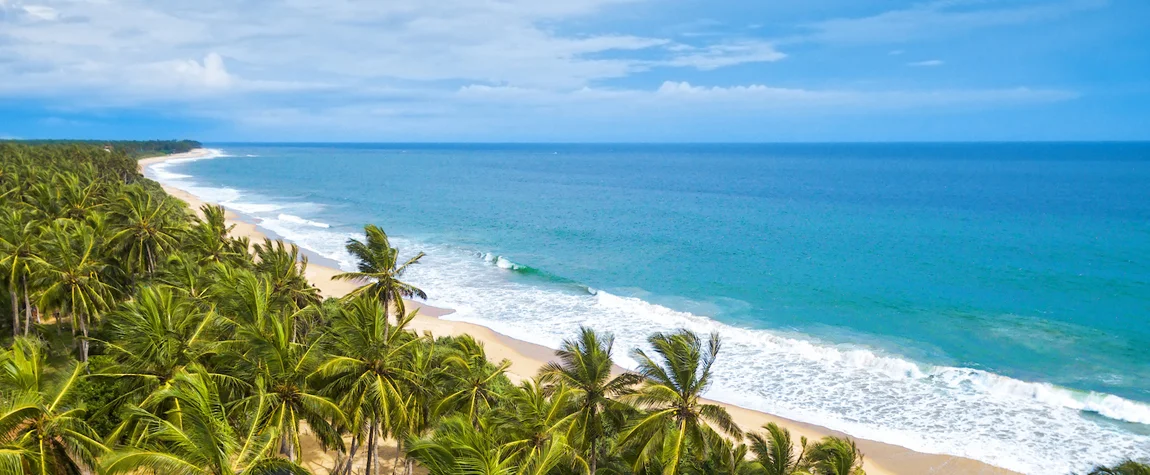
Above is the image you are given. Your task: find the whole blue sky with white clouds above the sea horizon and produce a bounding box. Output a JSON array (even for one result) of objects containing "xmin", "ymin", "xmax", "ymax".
[{"xmin": 0, "ymin": 0, "xmax": 1150, "ymax": 143}]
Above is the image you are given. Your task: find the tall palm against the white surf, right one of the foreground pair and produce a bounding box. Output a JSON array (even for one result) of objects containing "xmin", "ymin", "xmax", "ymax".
[{"xmin": 620, "ymin": 330, "xmax": 743, "ymax": 475}]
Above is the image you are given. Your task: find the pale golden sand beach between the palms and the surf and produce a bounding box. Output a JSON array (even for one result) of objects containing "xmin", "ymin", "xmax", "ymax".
[{"xmin": 138, "ymin": 148, "xmax": 1015, "ymax": 475}]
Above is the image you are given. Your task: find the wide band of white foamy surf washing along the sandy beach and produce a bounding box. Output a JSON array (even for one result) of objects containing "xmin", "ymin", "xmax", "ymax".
[{"xmin": 146, "ymin": 155, "xmax": 1150, "ymax": 474}]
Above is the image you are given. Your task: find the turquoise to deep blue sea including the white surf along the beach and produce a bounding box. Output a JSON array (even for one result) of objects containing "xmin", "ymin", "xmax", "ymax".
[{"xmin": 147, "ymin": 144, "xmax": 1150, "ymax": 474}]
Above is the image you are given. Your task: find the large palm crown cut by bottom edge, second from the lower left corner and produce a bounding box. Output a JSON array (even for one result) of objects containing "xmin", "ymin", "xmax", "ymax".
[{"xmin": 104, "ymin": 371, "xmax": 311, "ymax": 475}]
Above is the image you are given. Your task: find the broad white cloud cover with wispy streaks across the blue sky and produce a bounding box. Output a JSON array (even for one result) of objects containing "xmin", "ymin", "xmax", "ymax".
[{"xmin": 0, "ymin": 0, "xmax": 1074, "ymax": 138}]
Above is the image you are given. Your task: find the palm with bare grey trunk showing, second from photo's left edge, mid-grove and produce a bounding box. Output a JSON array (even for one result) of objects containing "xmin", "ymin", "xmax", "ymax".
[{"xmin": 40, "ymin": 221, "xmax": 112, "ymax": 362}]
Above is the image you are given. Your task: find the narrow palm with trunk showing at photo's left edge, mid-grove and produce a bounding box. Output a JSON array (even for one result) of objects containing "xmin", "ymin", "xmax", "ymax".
[{"xmin": 0, "ymin": 209, "xmax": 41, "ymax": 336}]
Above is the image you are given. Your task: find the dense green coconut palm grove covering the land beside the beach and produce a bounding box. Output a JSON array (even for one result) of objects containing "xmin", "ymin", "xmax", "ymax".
[{"xmin": 0, "ymin": 144, "xmax": 1143, "ymax": 475}]
